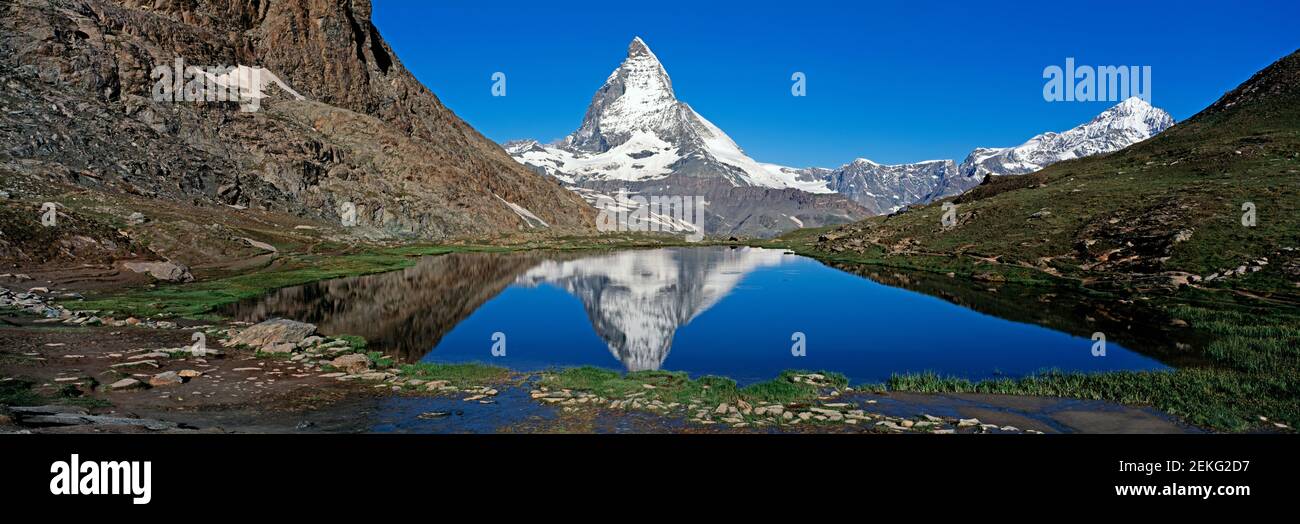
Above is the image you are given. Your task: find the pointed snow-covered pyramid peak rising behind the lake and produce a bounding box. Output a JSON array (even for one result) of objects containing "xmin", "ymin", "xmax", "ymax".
[{"xmin": 506, "ymin": 38, "xmax": 865, "ymax": 235}]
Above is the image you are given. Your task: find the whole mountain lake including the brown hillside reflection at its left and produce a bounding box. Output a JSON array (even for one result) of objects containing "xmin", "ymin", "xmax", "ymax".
[{"xmin": 228, "ymin": 247, "xmax": 1173, "ymax": 384}]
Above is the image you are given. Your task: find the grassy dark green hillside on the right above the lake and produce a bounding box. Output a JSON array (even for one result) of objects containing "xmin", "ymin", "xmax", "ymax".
[{"xmin": 814, "ymin": 52, "xmax": 1300, "ymax": 295}]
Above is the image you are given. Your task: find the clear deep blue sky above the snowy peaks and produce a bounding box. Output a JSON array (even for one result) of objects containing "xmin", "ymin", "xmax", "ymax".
[{"xmin": 373, "ymin": 0, "xmax": 1300, "ymax": 166}]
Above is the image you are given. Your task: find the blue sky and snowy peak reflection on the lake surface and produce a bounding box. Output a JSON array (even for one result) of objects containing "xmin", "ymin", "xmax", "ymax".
[{"xmin": 424, "ymin": 247, "xmax": 1164, "ymax": 382}]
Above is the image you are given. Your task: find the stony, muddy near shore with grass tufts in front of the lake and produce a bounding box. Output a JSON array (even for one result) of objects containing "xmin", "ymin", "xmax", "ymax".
[{"xmin": 0, "ymin": 319, "xmax": 1195, "ymax": 434}]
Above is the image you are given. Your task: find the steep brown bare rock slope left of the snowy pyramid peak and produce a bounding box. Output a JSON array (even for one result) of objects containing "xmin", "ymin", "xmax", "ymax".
[{"xmin": 0, "ymin": 0, "xmax": 594, "ymax": 244}]
